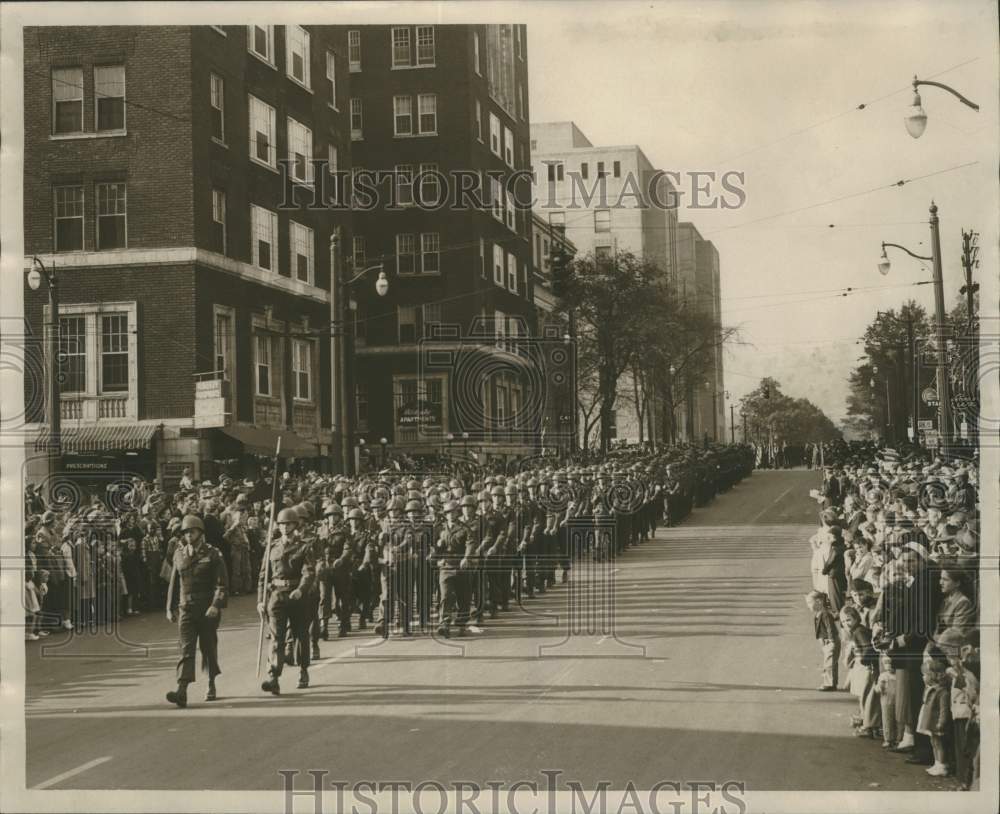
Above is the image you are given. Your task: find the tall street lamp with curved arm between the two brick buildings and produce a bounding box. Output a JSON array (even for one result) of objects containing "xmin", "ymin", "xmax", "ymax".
[{"xmin": 330, "ymin": 226, "xmax": 389, "ymax": 474}]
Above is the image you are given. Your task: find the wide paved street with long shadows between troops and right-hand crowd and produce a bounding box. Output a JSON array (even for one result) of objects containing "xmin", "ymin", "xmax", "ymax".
[{"xmin": 27, "ymin": 470, "xmax": 948, "ymax": 790}]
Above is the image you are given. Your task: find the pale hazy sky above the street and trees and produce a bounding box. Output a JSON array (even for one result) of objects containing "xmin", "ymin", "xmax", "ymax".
[{"xmin": 517, "ymin": 0, "xmax": 998, "ymax": 420}]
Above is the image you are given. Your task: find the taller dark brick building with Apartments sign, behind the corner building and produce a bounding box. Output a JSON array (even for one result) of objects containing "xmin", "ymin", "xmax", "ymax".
[{"xmin": 340, "ymin": 25, "xmax": 545, "ymax": 456}]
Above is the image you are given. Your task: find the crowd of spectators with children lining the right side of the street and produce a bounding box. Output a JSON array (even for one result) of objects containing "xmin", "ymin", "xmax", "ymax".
[{"xmin": 806, "ymin": 443, "xmax": 980, "ymax": 790}]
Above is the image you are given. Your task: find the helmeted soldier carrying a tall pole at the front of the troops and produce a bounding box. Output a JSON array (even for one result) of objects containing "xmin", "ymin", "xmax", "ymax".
[{"xmin": 257, "ymin": 507, "xmax": 316, "ymax": 695}]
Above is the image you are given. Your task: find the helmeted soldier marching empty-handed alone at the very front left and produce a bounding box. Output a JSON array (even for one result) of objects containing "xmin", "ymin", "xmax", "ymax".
[{"xmin": 167, "ymin": 514, "xmax": 229, "ymax": 707}]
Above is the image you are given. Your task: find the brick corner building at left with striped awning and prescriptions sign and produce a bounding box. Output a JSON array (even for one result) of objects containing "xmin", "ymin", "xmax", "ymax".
[{"xmin": 24, "ymin": 26, "xmax": 350, "ymax": 490}]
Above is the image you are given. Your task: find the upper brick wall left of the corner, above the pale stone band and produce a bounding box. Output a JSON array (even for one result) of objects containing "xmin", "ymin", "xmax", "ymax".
[{"xmin": 24, "ymin": 26, "xmax": 194, "ymax": 254}]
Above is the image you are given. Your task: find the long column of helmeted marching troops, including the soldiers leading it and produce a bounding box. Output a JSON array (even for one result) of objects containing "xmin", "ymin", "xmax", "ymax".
[{"xmin": 167, "ymin": 445, "xmax": 754, "ymax": 707}]
